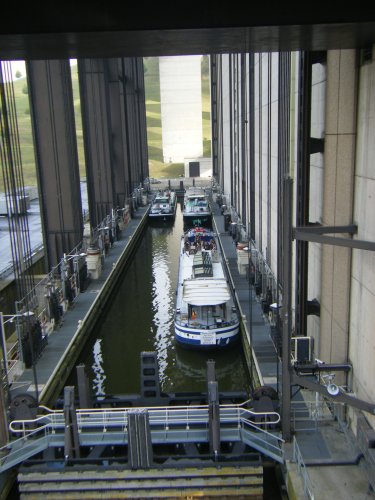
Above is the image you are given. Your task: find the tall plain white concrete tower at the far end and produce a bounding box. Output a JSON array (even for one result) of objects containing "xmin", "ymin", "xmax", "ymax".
[{"xmin": 159, "ymin": 56, "xmax": 203, "ymax": 163}]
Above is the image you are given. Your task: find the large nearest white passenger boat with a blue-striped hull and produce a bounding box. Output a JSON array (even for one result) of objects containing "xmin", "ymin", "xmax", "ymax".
[{"xmin": 174, "ymin": 227, "xmax": 240, "ymax": 349}]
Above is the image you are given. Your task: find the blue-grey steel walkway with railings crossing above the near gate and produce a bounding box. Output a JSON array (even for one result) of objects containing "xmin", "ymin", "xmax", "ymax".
[{"xmin": 0, "ymin": 405, "xmax": 284, "ymax": 473}]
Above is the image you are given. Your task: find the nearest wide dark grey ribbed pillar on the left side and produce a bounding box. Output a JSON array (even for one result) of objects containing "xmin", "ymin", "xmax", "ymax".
[{"xmin": 26, "ymin": 60, "xmax": 83, "ymax": 269}]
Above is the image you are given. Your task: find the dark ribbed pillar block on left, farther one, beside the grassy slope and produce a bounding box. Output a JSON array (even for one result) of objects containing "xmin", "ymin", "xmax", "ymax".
[{"xmin": 78, "ymin": 58, "xmax": 148, "ymax": 227}]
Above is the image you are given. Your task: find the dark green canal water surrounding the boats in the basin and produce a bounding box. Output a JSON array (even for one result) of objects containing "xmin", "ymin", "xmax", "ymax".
[{"xmin": 73, "ymin": 203, "xmax": 250, "ymax": 396}]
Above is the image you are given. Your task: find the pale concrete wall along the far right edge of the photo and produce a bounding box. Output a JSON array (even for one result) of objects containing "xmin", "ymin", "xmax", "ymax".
[{"xmin": 349, "ymin": 48, "xmax": 375, "ymax": 426}]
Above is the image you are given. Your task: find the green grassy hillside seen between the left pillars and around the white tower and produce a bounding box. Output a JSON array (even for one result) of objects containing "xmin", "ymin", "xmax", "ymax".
[{"xmin": 0, "ymin": 56, "xmax": 211, "ymax": 191}]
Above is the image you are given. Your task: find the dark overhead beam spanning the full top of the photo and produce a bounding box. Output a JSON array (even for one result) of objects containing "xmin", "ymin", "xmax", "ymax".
[{"xmin": 0, "ymin": 23, "xmax": 375, "ymax": 60}]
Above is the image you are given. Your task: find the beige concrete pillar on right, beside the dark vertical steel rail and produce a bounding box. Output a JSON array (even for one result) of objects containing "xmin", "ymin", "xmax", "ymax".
[{"xmin": 316, "ymin": 50, "xmax": 357, "ymax": 383}]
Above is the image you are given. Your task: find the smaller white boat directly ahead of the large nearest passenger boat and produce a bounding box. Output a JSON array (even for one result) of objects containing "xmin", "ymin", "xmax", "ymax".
[{"xmin": 182, "ymin": 187, "xmax": 212, "ymax": 229}]
